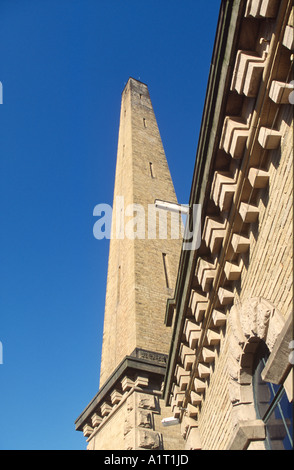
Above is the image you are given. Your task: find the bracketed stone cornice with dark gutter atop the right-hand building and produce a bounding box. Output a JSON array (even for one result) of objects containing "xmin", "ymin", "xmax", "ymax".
[{"xmin": 164, "ymin": 0, "xmax": 293, "ymax": 430}]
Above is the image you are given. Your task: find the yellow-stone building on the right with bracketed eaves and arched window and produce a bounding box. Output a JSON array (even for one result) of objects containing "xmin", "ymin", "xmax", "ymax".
[{"xmin": 163, "ymin": 0, "xmax": 294, "ymax": 450}]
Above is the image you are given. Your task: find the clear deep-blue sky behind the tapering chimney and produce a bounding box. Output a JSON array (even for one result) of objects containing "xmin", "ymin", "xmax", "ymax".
[{"xmin": 0, "ymin": 0, "xmax": 220, "ymax": 450}]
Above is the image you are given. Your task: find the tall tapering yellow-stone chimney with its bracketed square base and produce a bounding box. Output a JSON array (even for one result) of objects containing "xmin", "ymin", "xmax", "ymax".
[{"xmin": 76, "ymin": 78, "xmax": 183, "ymax": 450}]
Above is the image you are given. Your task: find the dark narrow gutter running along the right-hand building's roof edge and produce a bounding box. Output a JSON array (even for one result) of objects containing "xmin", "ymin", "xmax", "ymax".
[{"xmin": 163, "ymin": 0, "xmax": 245, "ymax": 403}]
